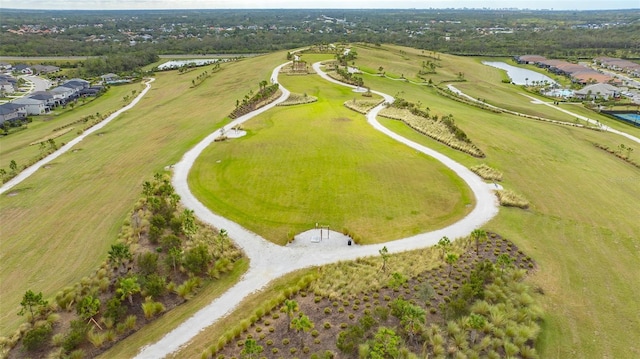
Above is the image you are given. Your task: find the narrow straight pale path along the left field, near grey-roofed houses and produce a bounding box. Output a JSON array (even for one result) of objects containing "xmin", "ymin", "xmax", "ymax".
[{"xmin": 0, "ymin": 78, "xmax": 156, "ymax": 194}]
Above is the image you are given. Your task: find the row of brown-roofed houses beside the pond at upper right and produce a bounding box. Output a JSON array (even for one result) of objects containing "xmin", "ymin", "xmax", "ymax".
[{"xmin": 514, "ymin": 55, "xmax": 619, "ymax": 85}]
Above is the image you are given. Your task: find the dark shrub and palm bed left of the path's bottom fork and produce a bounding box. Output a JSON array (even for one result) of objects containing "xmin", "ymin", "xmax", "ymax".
[{"xmin": 0, "ymin": 174, "xmax": 243, "ymax": 358}]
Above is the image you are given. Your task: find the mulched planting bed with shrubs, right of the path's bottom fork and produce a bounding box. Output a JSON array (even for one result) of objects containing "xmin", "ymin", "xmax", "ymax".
[{"xmin": 202, "ymin": 233, "xmax": 541, "ymax": 359}]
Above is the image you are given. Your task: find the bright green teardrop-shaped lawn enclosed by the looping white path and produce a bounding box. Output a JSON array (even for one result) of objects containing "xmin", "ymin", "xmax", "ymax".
[{"xmin": 190, "ymin": 75, "xmax": 474, "ymax": 248}]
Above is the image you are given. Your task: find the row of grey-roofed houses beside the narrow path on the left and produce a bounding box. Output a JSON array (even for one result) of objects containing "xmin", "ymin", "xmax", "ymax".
[{"xmin": 0, "ymin": 78, "xmax": 103, "ymax": 126}]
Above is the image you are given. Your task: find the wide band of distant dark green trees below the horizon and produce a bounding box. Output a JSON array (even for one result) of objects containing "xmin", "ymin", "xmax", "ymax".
[{"xmin": 0, "ymin": 9, "xmax": 640, "ymax": 60}]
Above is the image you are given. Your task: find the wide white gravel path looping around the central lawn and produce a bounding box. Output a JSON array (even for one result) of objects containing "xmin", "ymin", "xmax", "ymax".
[{"xmin": 136, "ymin": 63, "xmax": 498, "ymax": 359}]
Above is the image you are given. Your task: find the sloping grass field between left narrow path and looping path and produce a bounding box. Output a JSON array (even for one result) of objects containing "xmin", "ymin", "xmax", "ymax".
[{"xmin": 0, "ymin": 53, "xmax": 285, "ymax": 335}]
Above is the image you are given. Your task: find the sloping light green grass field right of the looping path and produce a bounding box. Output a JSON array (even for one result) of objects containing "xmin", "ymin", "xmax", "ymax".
[{"xmin": 176, "ymin": 45, "xmax": 640, "ymax": 358}]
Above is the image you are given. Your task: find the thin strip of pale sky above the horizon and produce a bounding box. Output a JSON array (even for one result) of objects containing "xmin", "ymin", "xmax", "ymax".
[{"xmin": 0, "ymin": 0, "xmax": 640, "ymax": 10}]
